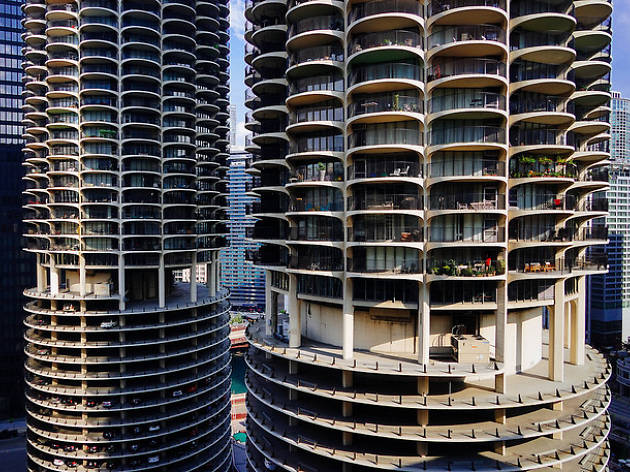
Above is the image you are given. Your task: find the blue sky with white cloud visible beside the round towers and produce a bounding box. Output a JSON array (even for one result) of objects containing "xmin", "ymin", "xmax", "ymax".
[{"xmin": 230, "ymin": 0, "xmax": 630, "ymax": 146}]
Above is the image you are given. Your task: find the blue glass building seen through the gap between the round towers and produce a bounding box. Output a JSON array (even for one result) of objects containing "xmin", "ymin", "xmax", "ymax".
[{"xmin": 220, "ymin": 151, "xmax": 265, "ymax": 311}]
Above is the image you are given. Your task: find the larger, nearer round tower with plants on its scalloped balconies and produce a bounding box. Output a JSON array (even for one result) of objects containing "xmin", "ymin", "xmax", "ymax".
[{"xmin": 245, "ymin": 0, "xmax": 612, "ymax": 466}]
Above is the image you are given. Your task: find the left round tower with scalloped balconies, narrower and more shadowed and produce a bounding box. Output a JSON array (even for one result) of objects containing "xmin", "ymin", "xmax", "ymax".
[{"xmin": 24, "ymin": 0, "xmax": 231, "ymax": 472}]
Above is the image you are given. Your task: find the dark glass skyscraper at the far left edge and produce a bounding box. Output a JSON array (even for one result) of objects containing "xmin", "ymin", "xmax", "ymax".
[{"xmin": 0, "ymin": 0, "xmax": 35, "ymax": 417}]
